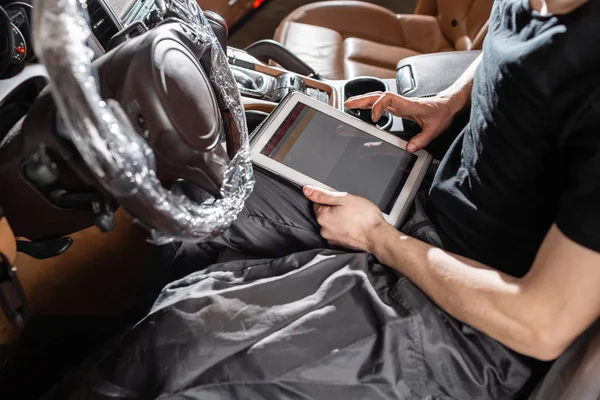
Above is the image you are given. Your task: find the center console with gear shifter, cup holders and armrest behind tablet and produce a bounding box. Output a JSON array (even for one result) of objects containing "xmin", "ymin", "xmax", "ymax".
[{"xmin": 228, "ymin": 43, "xmax": 481, "ymax": 159}]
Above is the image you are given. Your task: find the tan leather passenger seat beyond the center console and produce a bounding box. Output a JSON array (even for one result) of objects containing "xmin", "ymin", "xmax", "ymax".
[{"xmin": 275, "ymin": 0, "xmax": 493, "ymax": 79}]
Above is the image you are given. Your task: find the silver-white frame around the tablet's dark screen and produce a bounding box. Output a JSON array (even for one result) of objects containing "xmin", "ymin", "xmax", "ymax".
[{"xmin": 250, "ymin": 92, "xmax": 431, "ymax": 226}]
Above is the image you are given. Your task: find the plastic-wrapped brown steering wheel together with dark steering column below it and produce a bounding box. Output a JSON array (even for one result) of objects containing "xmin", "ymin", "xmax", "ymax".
[{"xmin": 0, "ymin": 0, "xmax": 254, "ymax": 243}]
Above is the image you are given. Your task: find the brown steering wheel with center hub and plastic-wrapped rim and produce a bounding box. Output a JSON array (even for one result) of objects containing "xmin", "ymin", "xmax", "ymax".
[{"xmin": 34, "ymin": 0, "xmax": 254, "ymax": 243}]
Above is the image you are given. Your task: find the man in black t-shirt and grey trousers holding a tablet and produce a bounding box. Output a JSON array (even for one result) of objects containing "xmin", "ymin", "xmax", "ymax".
[{"xmin": 36, "ymin": 0, "xmax": 600, "ymax": 399}]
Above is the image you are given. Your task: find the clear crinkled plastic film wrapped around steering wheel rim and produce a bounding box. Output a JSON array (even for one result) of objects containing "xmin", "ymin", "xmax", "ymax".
[{"xmin": 34, "ymin": 0, "xmax": 254, "ymax": 244}]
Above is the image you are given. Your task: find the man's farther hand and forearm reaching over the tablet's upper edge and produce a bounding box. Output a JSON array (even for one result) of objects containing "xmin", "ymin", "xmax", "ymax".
[{"xmin": 344, "ymin": 55, "xmax": 482, "ymax": 153}]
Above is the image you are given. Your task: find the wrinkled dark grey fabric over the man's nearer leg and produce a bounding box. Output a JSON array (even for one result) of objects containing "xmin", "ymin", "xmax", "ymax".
[{"xmin": 46, "ymin": 250, "xmax": 529, "ymax": 400}]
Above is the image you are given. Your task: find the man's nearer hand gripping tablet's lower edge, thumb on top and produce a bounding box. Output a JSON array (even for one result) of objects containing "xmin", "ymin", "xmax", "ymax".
[{"xmin": 303, "ymin": 186, "xmax": 386, "ymax": 252}]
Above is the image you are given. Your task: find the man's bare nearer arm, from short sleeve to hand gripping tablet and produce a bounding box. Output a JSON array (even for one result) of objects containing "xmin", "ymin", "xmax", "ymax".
[{"xmin": 304, "ymin": 187, "xmax": 600, "ymax": 360}]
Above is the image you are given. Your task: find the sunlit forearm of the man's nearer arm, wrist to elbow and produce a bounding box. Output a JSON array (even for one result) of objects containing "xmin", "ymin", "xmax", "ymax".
[{"xmin": 371, "ymin": 224, "xmax": 544, "ymax": 358}]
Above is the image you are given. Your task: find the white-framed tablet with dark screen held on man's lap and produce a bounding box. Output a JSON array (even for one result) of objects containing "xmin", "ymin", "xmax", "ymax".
[{"xmin": 251, "ymin": 92, "xmax": 431, "ymax": 226}]
